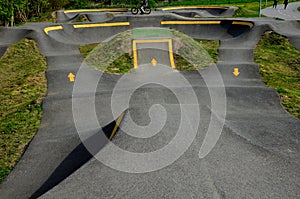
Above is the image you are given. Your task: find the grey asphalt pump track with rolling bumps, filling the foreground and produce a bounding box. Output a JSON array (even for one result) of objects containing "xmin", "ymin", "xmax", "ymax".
[{"xmin": 0, "ymin": 5, "xmax": 300, "ymax": 199}]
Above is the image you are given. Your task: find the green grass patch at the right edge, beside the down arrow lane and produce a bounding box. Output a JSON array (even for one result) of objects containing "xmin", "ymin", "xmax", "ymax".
[{"xmin": 255, "ymin": 32, "xmax": 300, "ymax": 119}]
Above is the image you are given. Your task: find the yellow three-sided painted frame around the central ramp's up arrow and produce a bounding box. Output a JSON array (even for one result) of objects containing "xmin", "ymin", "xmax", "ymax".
[{"xmin": 132, "ymin": 39, "xmax": 175, "ymax": 69}]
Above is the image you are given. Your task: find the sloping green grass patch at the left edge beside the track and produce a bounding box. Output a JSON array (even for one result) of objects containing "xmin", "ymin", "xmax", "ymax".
[{"xmin": 0, "ymin": 39, "xmax": 46, "ymax": 182}]
